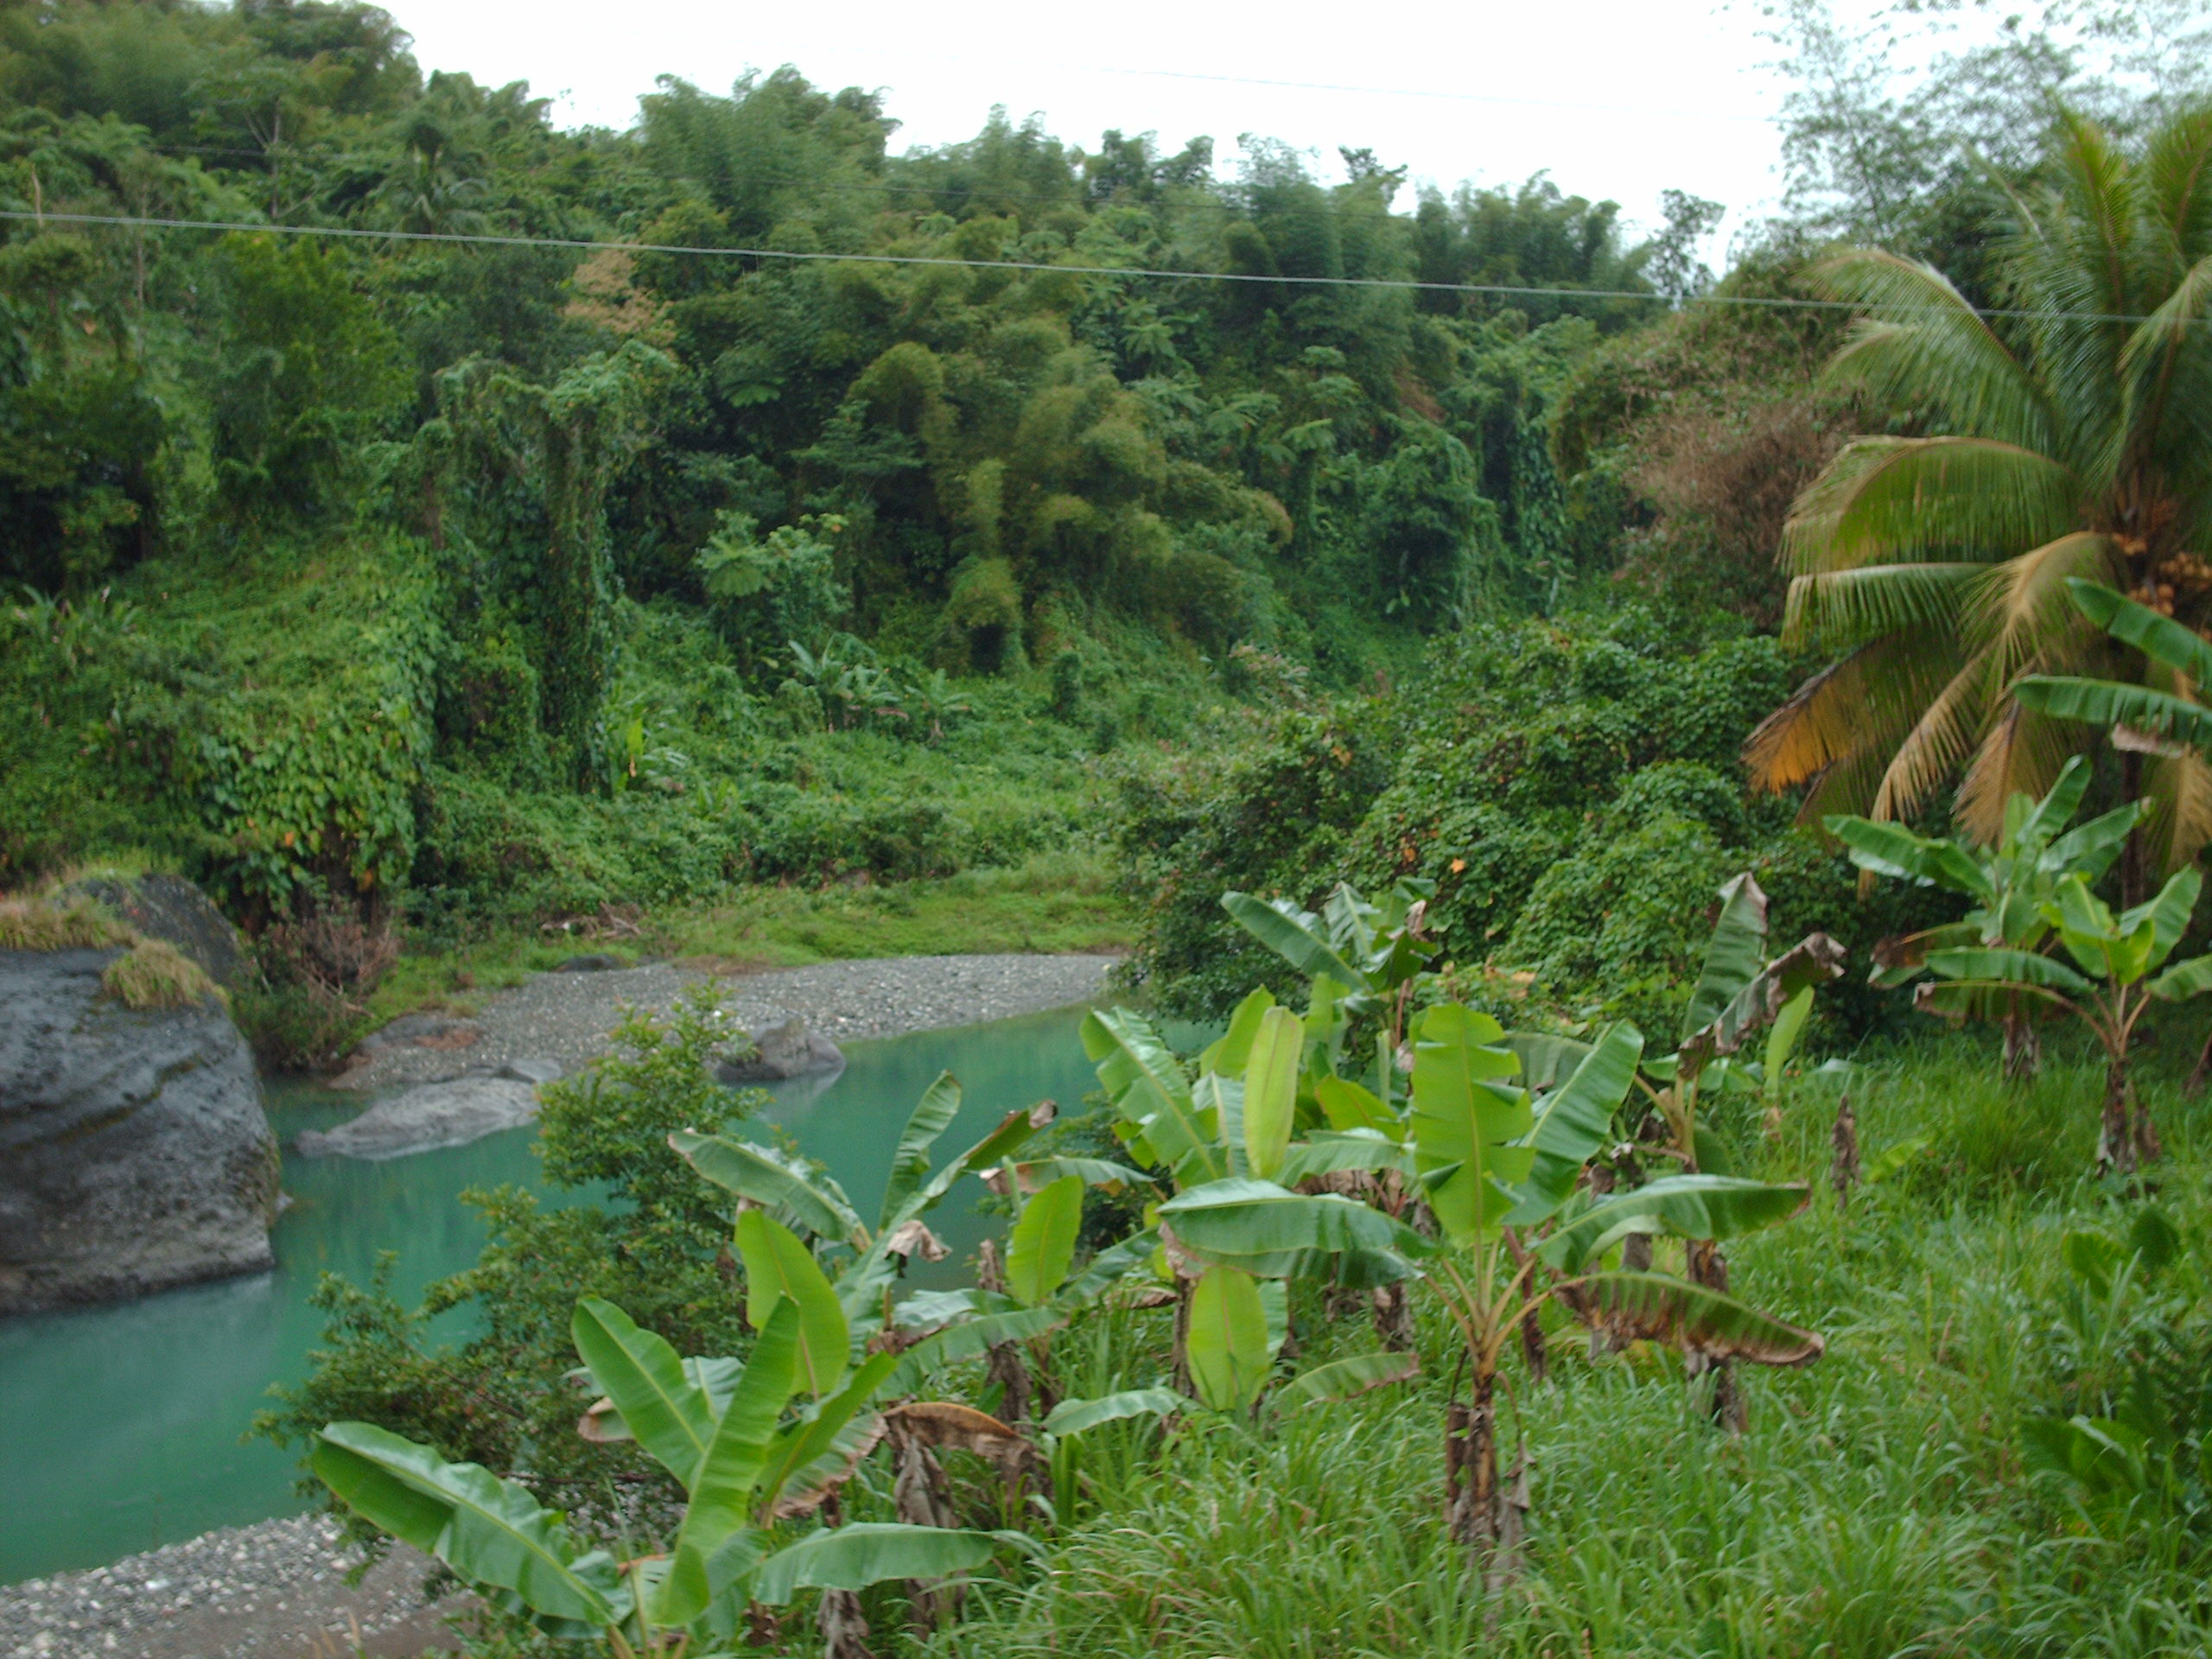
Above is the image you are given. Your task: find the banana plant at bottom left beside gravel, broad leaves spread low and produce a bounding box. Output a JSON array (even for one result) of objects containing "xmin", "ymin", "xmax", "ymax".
[{"xmin": 312, "ymin": 1299, "xmax": 998, "ymax": 1659}]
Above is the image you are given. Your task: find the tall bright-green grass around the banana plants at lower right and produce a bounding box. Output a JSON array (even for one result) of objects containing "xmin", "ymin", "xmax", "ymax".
[{"xmin": 919, "ymin": 1039, "xmax": 2212, "ymax": 1659}]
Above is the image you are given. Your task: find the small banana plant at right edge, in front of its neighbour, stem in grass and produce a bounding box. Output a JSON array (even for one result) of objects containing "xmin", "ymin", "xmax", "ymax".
[{"xmin": 1913, "ymin": 869, "xmax": 2212, "ymax": 1174}]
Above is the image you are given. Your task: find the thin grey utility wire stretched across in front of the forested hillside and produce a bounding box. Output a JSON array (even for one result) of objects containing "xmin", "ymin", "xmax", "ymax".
[{"xmin": 0, "ymin": 208, "xmax": 2177, "ymax": 323}]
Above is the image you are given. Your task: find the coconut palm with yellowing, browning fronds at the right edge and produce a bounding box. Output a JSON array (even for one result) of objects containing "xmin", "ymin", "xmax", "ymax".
[{"xmin": 1745, "ymin": 108, "xmax": 2212, "ymax": 885}]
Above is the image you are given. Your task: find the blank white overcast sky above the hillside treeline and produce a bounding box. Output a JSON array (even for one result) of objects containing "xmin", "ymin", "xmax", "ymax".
[{"xmin": 387, "ymin": 0, "xmax": 1781, "ymax": 243}]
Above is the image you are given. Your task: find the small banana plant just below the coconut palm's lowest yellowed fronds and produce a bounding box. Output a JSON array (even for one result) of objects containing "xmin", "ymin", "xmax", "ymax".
[{"xmin": 1825, "ymin": 754, "xmax": 2150, "ymax": 1079}]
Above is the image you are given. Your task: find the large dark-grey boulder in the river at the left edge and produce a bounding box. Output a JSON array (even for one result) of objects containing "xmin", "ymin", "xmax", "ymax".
[{"xmin": 0, "ymin": 949, "xmax": 276, "ymax": 1314}]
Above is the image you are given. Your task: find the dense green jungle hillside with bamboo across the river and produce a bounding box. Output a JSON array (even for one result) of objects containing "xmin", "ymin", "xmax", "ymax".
[{"xmin": 0, "ymin": 3, "xmax": 1725, "ymax": 986}]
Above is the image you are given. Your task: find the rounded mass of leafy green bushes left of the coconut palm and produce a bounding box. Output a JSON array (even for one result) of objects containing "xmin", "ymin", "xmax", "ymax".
[{"xmin": 1119, "ymin": 606, "xmax": 1955, "ymax": 1027}]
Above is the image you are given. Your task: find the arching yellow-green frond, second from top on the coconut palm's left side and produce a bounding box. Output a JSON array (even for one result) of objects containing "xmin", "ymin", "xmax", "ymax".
[{"xmin": 1781, "ymin": 438, "xmax": 2079, "ymax": 573}]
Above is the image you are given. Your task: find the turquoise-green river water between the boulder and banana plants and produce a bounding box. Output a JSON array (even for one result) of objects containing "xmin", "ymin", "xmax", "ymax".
[{"xmin": 0, "ymin": 1008, "xmax": 1095, "ymax": 1584}]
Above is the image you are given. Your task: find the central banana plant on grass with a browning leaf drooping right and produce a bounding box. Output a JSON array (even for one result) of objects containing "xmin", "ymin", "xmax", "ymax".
[{"xmin": 1161, "ymin": 1004, "xmax": 1822, "ymax": 1584}]
